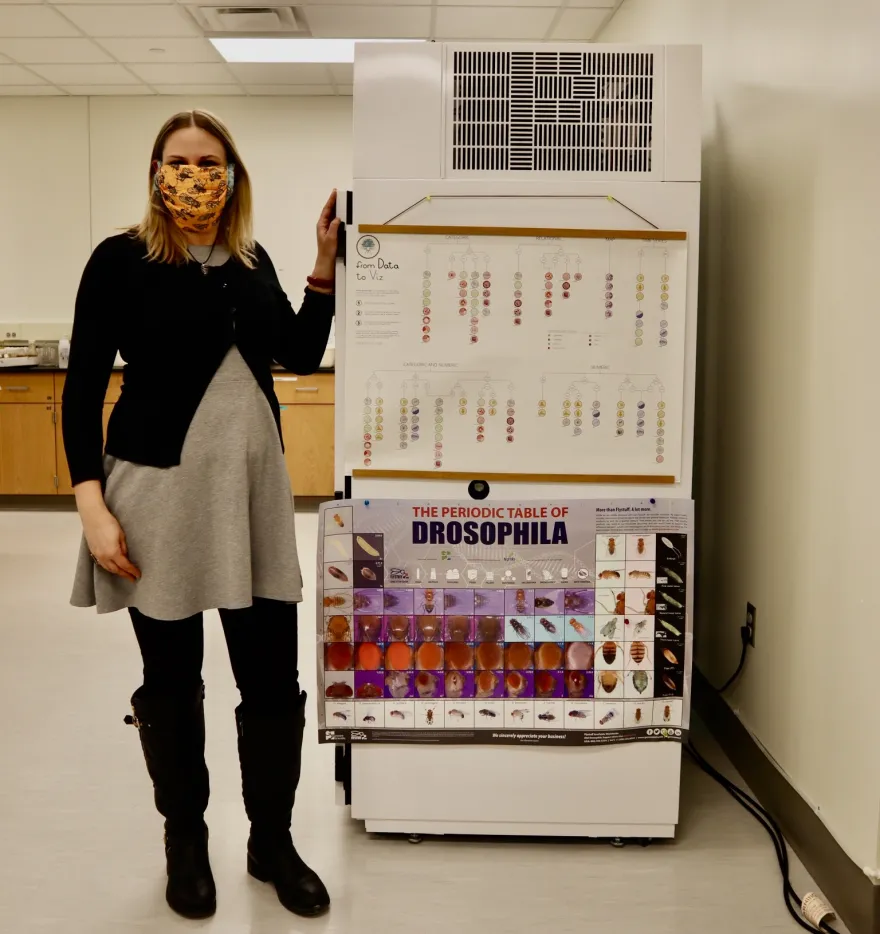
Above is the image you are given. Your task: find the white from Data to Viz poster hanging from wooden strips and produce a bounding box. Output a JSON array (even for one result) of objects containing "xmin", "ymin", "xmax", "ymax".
[{"xmin": 345, "ymin": 227, "xmax": 687, "ymax": 479}]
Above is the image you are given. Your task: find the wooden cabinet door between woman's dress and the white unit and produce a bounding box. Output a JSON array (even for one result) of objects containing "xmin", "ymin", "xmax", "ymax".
[{"xmin": 281, "ymin": 405, "xmax": 334, "ymax": 496}]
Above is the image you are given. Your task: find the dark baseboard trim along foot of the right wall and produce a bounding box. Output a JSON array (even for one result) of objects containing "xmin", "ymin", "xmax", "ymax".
[{"xmin": 693, "ymin": 668, "xmax": 880, "ymax": 934}]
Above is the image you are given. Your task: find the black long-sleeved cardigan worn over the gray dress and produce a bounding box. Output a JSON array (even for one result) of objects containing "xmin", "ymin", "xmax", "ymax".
[{"xmin": 62, "ymin": 234, "xmax": 334, "ymax": 485}]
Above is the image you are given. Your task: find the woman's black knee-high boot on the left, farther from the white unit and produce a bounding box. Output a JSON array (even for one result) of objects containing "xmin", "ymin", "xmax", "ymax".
[{"xmin": 125, "ymin": 685, "xmax": 217, "ymax": 918}]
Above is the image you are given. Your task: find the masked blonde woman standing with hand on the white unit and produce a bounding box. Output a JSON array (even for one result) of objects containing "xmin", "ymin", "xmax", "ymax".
[{"xmin": 63, "ymin": 110, "xmax": 339, "ymax": 917}]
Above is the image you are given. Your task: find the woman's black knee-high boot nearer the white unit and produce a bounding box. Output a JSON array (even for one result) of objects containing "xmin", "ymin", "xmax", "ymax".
[{"xmin": 235, "ymin": 693, "xmax": 330, "ymax": 917}]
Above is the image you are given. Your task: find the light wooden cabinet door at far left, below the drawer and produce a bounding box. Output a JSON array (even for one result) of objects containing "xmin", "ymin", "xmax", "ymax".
[{"xmin": 0, "ymin": 403, "xmax": 55, "ymax": 496}]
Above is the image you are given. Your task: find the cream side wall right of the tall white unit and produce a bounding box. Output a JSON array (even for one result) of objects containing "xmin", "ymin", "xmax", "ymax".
[{"xmin": 598, "ymin": 0, "xmax": 880, "ymax": 866}]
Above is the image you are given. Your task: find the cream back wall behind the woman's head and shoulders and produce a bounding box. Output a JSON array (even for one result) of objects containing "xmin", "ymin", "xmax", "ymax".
[{"xmin": 0, "ymin": 97, "xmax": 351, "ymax": 337}]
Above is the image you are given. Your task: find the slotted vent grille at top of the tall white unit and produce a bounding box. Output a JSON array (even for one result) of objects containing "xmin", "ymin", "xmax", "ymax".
[{"xmin": 452, "ymin": 51, "xmax": 654, "ymax": 174}]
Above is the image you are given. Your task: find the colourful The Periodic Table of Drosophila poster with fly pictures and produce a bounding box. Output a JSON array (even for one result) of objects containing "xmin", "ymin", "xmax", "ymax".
[{"xmin": 317, "ymin": 500, "xmax": 692, "ymax": 746}]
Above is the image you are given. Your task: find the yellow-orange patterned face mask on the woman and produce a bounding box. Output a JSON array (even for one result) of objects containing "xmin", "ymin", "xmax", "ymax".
[{"xmin": 154, "ymin": 165, "xmax": 235, "ymax": 233}]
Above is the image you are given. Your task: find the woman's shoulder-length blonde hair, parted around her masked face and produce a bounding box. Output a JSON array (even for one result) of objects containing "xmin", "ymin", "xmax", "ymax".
[{"xmin": 129, "ymin": 110, "xmax": 255, "ymax": 269}]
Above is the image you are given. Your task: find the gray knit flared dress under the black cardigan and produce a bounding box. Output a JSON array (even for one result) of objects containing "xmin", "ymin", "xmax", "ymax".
[{"xmin": 71, "ymin": 248, "xmax": 302, "ymax": 620}]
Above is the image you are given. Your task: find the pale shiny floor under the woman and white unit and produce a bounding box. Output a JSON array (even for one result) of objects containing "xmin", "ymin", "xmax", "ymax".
[{"xmin": 0, "ymin": 512, "xmax": 844, "ymax": 934}]
